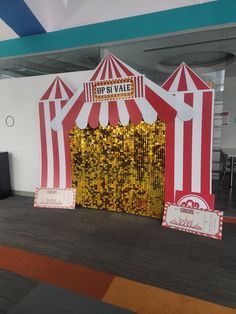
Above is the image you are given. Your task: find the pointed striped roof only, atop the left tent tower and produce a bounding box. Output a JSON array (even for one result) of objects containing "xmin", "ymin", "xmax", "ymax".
[{"xmin": 40, "ymin": 76, "xmax": 74, "ymax": 101}]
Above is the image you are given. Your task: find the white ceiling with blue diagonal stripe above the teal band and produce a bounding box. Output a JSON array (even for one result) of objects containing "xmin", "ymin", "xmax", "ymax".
[{"xmin": 0, "ymin": 0, "xmax": 215, "ymax": 40}]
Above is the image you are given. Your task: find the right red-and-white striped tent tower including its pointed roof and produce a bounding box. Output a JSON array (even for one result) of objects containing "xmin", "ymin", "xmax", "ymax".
[{"xmin": 162, "ymin": 63, "xmax": 214, "ymax": 206}]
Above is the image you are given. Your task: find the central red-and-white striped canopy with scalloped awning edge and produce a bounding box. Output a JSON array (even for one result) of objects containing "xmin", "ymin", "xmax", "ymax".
[{"xmin": 52, "ymin": 54, "xmax": 192, "ymax": 130}]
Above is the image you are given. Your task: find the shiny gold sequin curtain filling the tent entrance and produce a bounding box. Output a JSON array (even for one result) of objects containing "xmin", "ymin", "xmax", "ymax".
[{"xmin": 70, "ymin": 122, "xmax": 165, "ymax": 218}]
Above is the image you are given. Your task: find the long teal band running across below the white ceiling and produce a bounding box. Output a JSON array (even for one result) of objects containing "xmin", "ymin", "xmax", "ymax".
[{"xmin": 0, "ymin": 0, "xmax": 236, "ymax": 58}]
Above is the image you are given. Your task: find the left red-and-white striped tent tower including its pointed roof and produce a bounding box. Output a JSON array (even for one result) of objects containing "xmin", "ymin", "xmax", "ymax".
[{"xmin": 39, "ymin": 77, "xmax": 73, "ymax": 188}]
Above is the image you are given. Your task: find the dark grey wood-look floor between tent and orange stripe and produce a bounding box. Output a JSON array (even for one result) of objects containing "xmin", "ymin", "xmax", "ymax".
[{"xmin": 0, "ymin": 196, "xmax": 236, "ymax": 307}]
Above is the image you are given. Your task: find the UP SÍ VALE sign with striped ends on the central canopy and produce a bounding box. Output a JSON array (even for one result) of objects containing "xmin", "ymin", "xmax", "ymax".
[{"xmin": 84, "ymin": 75, "xmax": 145, "ymax": 102}]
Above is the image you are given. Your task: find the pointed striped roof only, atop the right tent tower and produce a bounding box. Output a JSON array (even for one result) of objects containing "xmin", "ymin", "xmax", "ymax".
[{"xmin": 162, "ymin": 62, "xmax": 210, "ymax": 92}]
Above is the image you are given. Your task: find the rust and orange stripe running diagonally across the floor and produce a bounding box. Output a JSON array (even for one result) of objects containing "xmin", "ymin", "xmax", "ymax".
[{"xmin": 0, "ymin": 246, "xmax": 236, "ymax": 314}]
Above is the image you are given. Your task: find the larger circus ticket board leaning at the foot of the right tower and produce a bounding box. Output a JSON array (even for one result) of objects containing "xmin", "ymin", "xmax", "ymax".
[{"xmin": 162, "ymin": 203, "xmax": 223, "ymax": 240}]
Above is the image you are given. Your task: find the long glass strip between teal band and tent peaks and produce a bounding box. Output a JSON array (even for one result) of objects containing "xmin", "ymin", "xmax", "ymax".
[{"xmin": 0, "ymin": 26, "xmax": 236, "ymax": 83}]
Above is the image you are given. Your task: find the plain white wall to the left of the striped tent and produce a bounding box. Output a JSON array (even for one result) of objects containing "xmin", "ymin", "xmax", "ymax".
[{"xmin": 0, "ymin": 71, "xmax": 92, "ymax": 192}]
